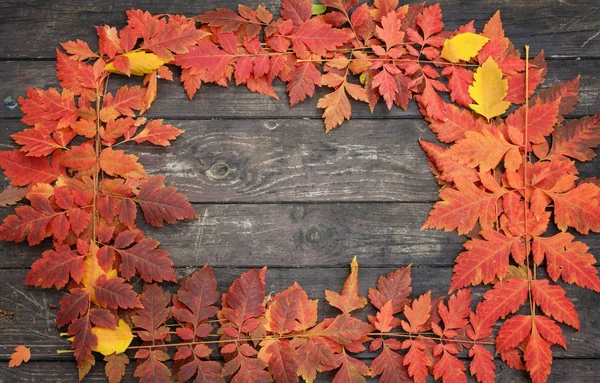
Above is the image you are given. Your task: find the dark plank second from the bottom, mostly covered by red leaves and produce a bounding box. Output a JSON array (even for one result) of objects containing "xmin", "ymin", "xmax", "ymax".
[{"xmin": 0, "ymin": 268, "xmax": 600, "ymax": 360}]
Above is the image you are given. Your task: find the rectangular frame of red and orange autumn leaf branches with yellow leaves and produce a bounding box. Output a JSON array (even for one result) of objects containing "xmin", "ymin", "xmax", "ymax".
[{"xmin": 0, "ymin": 0, "xmax": 600, "ymax": 383}]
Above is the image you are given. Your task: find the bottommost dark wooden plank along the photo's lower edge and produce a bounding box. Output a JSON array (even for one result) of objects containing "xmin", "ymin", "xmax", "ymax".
[{"xmin": 0, "ymin": 359, "xmax": 600, "ymax": 383}]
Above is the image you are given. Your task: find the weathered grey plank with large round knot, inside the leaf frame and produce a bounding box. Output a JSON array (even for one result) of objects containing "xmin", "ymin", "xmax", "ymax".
[{"xmin": 0, "ymin": 120, "xmax": 600, "ymax": 203}]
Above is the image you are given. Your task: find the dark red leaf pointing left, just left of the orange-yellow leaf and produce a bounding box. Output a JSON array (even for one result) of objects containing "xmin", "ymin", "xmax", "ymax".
[{"xmin": 25, "ymin": 245, "xmax": 85, "ymax": 289}]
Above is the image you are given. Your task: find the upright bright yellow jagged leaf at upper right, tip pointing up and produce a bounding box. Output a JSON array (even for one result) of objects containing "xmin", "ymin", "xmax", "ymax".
[{"xmin": 469, "ymin": 57, "xmax": 510, "ymax": 120}]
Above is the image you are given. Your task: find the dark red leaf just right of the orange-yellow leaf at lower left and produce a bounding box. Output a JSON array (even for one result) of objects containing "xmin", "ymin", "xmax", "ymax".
[{"xmin": 94, "ymin": 275, "xmax": 141, "ymax": 309}]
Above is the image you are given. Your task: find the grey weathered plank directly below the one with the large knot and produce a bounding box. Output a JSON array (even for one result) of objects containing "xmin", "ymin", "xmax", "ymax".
[{"xmin": 0, "ymin": 203, "xmax": 600, "ymax": 270}]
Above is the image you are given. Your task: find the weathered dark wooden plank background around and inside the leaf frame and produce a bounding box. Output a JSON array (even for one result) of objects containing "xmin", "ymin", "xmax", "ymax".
[{"xmin": 0, "ymin": 0, "xmax": 600, "ymax": 383}]
